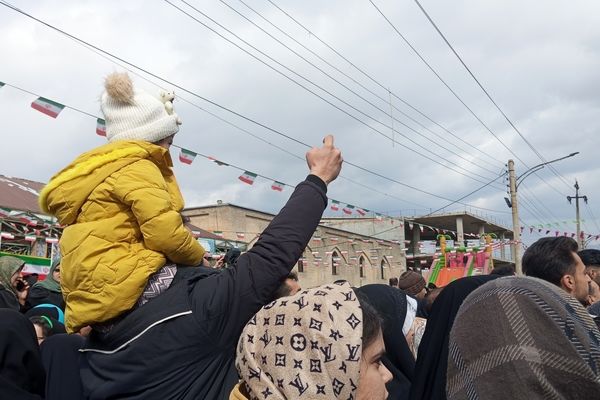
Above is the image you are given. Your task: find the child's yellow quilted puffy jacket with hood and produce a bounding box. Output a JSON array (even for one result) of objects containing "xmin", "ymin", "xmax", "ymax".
[{"xmin": 39, "ymin": 141, "xmax": 204, "ymax": 332}]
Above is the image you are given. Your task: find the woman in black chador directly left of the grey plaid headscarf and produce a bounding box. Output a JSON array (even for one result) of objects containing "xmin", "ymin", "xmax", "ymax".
[{"xmin": 409, "ymin": 275, "xmax": 499, "ymax": 400}]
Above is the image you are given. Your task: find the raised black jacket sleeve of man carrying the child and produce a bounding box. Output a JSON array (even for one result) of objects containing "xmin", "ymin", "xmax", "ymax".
[{"xmin": 191, "ymin": 175, "xmax": 327, "ymax": 346}]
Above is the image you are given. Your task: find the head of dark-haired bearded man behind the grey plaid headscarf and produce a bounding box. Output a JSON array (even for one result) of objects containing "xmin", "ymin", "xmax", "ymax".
[{"xmin": 523, "ymin": 236, "xmax": 590, "ymax": 303}]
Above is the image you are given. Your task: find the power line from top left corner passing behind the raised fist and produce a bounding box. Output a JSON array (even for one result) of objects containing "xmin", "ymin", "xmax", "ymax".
[{"xmin": 0, "ymin": 1, "xmax": 507, "ymax": 214}]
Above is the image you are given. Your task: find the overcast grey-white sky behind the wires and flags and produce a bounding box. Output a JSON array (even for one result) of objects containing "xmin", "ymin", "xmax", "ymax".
[{"xmin": 0, "ymin": 0, "xmax": 600, "ymax": 244}]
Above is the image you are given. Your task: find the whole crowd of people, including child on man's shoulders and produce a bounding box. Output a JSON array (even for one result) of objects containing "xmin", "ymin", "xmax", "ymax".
[{"xmin": 0, "ymin": 74, "xmax": 600, "ymax": 400}]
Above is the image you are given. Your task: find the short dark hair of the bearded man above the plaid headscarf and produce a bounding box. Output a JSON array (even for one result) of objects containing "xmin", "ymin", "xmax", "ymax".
[{"xmin": 523, "ymin": 236, "xmax": 577, "ymax": 286}]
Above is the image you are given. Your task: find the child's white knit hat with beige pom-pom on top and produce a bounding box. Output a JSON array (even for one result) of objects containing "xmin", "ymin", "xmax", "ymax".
[{"xmin": 101, "ymin": 73, "xmax": 181, "ymax": 143}]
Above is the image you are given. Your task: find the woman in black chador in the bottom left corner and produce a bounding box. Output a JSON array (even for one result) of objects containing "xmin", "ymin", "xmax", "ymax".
[{"xmin": 0, "ymin": 309, "xmax": 46, "ymax": 400}]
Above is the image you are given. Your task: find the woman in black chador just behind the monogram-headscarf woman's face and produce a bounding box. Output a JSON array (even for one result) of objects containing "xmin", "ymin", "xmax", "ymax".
[{"xmin": 356, "ymin": 284, "xmax": 416, "ymax": 399}]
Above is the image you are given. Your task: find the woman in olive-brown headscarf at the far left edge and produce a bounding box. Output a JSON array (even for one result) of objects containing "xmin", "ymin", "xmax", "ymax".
[{"xmin": 0, "ymin": 256, "xmax": 29, "ymax": 311}]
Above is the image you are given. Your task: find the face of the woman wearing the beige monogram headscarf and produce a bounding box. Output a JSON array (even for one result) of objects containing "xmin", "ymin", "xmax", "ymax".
[{"xmin": 356, "ymin": 331, "xmax": 392, "ymax": 400}]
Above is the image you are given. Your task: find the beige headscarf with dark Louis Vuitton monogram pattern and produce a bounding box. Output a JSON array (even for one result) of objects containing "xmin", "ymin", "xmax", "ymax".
[{"xmin": 236, "ymin": 282, "xmax": 363, "ymax": 400}]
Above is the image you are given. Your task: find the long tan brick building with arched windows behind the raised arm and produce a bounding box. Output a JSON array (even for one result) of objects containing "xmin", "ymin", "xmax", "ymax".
[{"xmin": 183, "ymin": 204, "xmax": 406, "ymax": 287}]
